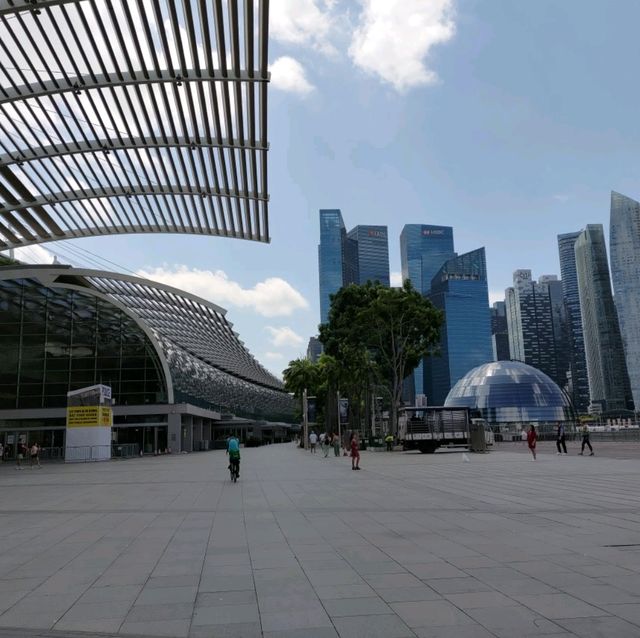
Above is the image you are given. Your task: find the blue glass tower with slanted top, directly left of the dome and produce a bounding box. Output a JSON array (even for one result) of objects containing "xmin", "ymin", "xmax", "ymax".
[{"xmin": 425, "ymin": 248, "xmax": 493, "ymax": 405}]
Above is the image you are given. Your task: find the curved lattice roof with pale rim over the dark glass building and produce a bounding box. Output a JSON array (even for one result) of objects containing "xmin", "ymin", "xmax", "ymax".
[{"xmin": 0, "ymin": 266, "xmax": 288, "ymax": 399}]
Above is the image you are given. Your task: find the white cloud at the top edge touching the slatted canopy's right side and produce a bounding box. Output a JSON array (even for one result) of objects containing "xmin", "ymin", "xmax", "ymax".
[{"xmin": 269, "ymin": 0, "xmax": 336, "ymax": 55}]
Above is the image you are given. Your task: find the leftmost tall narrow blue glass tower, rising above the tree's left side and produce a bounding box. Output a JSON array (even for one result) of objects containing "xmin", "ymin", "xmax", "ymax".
[{"xmin": 318, "ymin": 209, "xmax": 347, "ymax": 323}]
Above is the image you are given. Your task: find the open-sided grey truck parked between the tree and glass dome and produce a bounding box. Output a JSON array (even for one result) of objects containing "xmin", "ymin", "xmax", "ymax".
[{"xmin": 398, "ymin": 407, "xmax": 493, "ymax": 454}]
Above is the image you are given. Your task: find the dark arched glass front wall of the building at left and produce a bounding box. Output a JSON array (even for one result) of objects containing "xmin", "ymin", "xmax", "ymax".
[{"xmin": 0, "ymin": 279, "xmax": 167, "ymax": 409}]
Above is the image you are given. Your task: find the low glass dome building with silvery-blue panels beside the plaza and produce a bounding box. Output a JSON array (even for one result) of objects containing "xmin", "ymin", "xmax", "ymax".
[{"xmin": 445, "ymin": 361, "xmax": 574, "ymax": 431}]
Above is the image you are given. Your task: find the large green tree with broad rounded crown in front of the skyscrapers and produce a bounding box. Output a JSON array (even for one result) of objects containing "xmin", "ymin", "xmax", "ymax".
[{"xmin": 320, "ymin": 281, "xmax": 443, "ymax": 432}]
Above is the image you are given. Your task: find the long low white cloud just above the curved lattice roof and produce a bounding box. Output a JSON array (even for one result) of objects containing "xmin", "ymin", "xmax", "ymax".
[{"xmin": 137, "ymin": 266, "xmax": 309, "ymax": 317}]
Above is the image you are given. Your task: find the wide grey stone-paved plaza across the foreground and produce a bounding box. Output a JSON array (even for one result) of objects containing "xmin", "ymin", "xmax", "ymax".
[{"xmin": 0, "ymin": 444, "xmax": 640, "ymax": 638}]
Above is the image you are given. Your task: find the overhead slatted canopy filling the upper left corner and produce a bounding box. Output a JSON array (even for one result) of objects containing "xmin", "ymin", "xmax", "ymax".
[{"xmin": 0, "ymin": 0, "xmax": 269, "ymax": 249}]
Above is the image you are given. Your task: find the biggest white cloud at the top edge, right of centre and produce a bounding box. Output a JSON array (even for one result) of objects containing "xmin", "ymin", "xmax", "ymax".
[{"xmin": 349, "ymin": 0, "xmax": 455, "ymax": 91}]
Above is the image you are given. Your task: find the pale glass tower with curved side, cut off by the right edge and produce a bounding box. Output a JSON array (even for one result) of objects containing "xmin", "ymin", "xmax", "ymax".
[{"xmin": 609, "ymin": 192, "xmax": 640, "ymax": 406}]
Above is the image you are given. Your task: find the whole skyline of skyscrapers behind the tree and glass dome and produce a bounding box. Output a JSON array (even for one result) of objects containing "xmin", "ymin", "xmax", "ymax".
[{"xmin": 316, "ymin": 192, "xmax": 640, "ymax": 413}]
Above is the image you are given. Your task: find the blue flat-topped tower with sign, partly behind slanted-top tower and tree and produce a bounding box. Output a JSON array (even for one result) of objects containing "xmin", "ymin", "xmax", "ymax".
[{"xmin": 400, "ymin": 224, "xmax": 456, "ymax": 403}]
